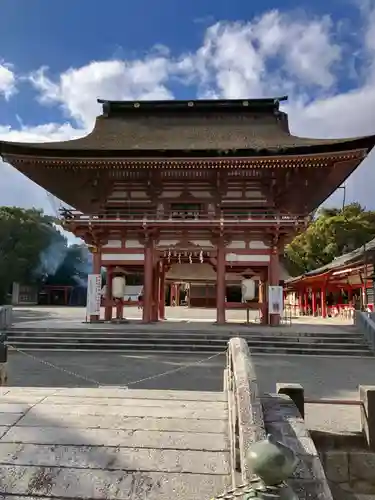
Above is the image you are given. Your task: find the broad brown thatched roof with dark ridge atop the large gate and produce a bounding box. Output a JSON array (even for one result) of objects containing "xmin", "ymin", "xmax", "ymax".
[{"xmin": 0, "ymin": 97, "xmax": 375, "ymax": 159}]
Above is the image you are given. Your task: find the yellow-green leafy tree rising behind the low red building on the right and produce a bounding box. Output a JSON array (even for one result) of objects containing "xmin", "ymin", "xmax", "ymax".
[{"xmin": 285, "ymin": 203, "xmax": 375, "ymax": 276}]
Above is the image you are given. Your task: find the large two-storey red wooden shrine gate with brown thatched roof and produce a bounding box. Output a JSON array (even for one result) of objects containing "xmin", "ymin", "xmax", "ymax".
[{"xmin": 0, "ymin": 98, "xmax": 375, "ymax": 324}]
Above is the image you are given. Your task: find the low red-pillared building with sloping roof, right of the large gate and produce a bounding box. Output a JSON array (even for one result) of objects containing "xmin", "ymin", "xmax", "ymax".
[{"xmin": 285, "ymin": 239, "xmax": 375, "ymax": 317}]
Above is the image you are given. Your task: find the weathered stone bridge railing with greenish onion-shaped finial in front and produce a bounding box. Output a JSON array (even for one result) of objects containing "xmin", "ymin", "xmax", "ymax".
[{"xmin": 224, "ymin": 338, "xmax": 332, "ymax": 500}]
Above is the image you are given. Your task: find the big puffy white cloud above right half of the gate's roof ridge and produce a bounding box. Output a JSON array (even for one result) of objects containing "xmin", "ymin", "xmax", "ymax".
[{"xmin": 180, "ymin": 10, "xmax": 342, "ymax": 98}]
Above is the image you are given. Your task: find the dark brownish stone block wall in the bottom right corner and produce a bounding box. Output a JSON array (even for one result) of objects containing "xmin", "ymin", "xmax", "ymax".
[{"xmin": 320, "ymin": 450, "xmax": 375, "ymax": 500}]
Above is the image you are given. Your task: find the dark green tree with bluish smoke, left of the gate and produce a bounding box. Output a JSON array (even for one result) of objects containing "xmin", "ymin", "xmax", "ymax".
[{"xmin": 0, "ymin": 207, "xmax": 66, "ymax": 303}]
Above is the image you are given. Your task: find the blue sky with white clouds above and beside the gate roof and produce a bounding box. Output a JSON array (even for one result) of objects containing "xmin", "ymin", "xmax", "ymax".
[{"xmin": 0, "ymin": 0, "xmax": 375, "ymax": 214}]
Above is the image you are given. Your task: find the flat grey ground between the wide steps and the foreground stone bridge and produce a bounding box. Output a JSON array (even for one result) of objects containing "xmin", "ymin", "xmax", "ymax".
[{"xmin": 9, "ymin": 352, "xmax": 375, "ymax": 431}]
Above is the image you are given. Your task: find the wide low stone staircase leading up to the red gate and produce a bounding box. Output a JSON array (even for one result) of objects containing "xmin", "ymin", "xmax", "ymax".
[{"xmin": 7, "ymin": 324, "xmax": 373, "ymax": 356}]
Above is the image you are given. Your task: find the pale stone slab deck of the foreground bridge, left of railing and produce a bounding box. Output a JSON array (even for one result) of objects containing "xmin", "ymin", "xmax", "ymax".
[{"xmin": 0, "ymin": 387, "xmax": 231, "ymax": 500}]
